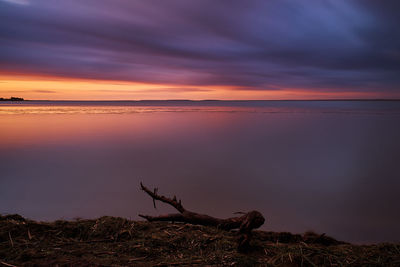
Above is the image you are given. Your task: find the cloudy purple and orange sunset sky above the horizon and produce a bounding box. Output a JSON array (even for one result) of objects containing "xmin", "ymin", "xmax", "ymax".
[{"xmin": 0, "ymin": 0, "xmax": 400, "ymax": 100}]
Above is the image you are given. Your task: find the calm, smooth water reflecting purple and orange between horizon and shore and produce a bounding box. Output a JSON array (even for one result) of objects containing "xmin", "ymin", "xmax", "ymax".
[{"xmin": 0, "ymin": 101, "xmax": 400, "ymax": 243}]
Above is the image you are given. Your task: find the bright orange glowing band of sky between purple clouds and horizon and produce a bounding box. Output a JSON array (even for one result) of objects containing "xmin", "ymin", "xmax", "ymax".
[{"xmin": 0, "ymin": 73, "xmax": 399, "ymax": 100}]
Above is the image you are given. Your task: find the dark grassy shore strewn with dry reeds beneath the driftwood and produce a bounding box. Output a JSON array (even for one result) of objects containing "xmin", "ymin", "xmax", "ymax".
[{"xmin": 0, "ymin": 214, "xmax": 400, "ymax": 266}]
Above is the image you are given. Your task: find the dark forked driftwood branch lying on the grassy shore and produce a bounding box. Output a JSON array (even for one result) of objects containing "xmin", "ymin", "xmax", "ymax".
[{"xmin": 139, "ymin": 183, "xmax": 265, "ymax": 251}]
